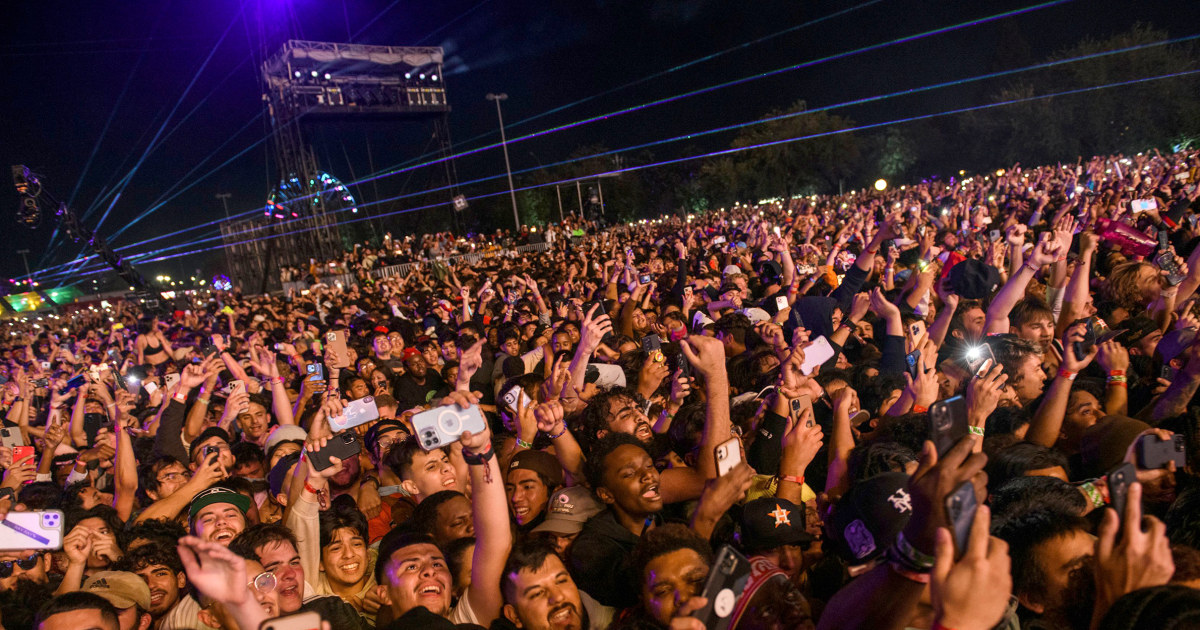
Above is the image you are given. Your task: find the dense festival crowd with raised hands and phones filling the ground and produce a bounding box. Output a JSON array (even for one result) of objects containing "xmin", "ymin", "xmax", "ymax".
[{"xmin": 0, "ymin": 151, "xmax": 1200, "ymax": 630}]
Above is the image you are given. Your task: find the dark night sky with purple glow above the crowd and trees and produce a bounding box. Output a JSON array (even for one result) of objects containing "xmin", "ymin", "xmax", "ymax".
[{"xmin": 0, "ymin": 0, "xmax": 1200, "ymax": 284}]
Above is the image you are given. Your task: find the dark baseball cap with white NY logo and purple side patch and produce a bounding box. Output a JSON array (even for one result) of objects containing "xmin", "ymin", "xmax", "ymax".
[{"xmin": 824, "ymin": 473, "xmax": 912, "ymax": 565}]
